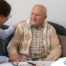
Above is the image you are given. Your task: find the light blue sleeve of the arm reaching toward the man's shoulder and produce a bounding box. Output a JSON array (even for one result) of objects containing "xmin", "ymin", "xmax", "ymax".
[{"xmin": 0, "ymin": 27, "xmax": 15, "ymax": 39}]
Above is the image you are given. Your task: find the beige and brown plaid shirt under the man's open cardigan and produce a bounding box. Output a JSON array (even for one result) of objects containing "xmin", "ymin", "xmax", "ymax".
[{"xmin": 30, "ymin": 24, "xmax": 44, "ymax": 58}]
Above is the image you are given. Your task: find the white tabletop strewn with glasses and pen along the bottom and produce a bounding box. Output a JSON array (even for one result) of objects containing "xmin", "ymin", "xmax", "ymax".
[{"xmin": 0, "ymin": 61, "xmax": 54, "ymax": 66}]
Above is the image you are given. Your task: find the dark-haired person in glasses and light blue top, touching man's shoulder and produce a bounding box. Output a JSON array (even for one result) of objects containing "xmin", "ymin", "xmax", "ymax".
[{"xmin": 0, "ymin": 0, "xmax": 24, "ymax": 62}]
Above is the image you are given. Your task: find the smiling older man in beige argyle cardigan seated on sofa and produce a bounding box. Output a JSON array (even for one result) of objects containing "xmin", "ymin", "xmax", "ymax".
[{"xmin": 8, "ymin": 4, "xmax": 61, "ymax": 61}]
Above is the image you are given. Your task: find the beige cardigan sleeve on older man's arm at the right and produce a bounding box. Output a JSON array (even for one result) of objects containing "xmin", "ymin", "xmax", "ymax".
[{"xmin": 44, "ymin": 27, "xmax": 62, "ymax": 61}]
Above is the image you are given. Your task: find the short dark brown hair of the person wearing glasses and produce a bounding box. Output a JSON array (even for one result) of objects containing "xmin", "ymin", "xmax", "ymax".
[{"xmin": 0, "ymin": 0, "xmax": 11, "ymax": 17}]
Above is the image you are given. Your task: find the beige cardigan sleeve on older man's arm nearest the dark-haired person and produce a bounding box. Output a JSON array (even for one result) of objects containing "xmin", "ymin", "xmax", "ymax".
[{"xmin": 7, "ymin": 25, "xmax": 22, "ymax": 56}]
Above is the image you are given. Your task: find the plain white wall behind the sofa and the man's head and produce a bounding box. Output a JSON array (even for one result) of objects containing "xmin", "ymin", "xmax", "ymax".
[{"xmin": 6, "ymin": 0, "xmax": 66, "ymax": 27}]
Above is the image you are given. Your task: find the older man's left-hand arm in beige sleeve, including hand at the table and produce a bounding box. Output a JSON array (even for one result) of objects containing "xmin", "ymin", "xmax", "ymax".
[{"xmin": 7, "ymin": 25, "xmax": 23, "ymax": 62}]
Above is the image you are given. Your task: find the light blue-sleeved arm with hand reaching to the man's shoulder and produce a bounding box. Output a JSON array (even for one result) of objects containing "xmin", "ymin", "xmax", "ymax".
[{"xmin": 0, "ymin": 20, "xmax": 26, "ymax": 39}]
